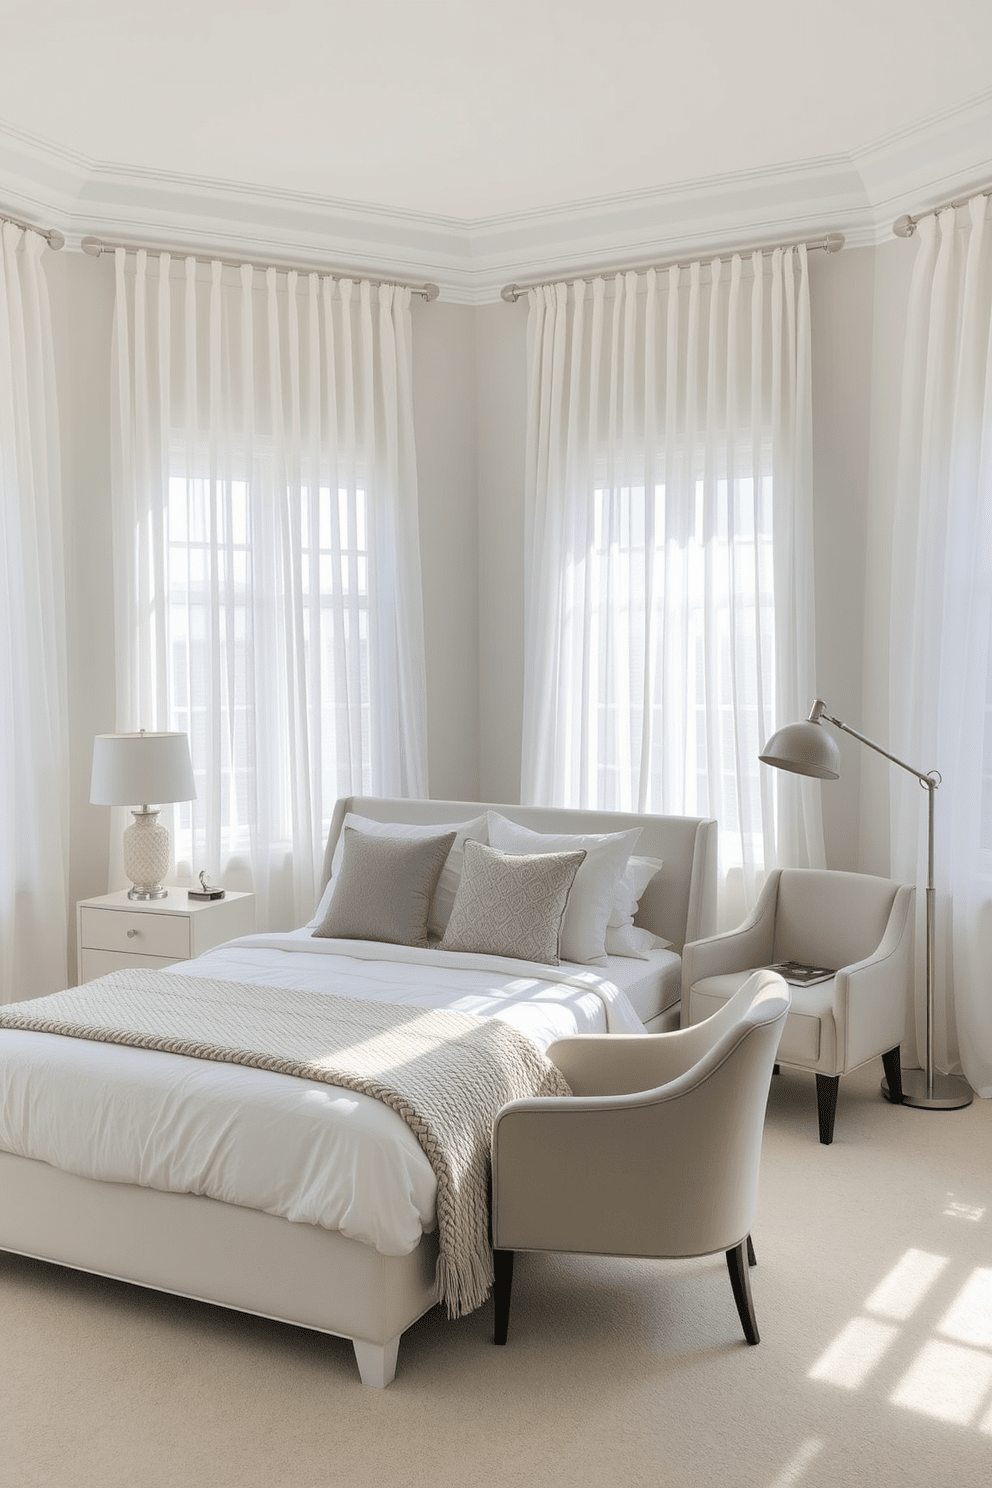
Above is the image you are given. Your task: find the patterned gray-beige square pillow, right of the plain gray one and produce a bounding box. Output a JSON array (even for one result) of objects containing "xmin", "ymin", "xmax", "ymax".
[{"xmin": 440, "ymin": 841, "xmax": 586, "ymax": 966}]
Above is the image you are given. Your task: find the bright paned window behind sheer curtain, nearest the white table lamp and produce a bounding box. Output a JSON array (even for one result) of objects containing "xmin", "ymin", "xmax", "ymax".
[{"xmin": 165, "ymin": 476, "xmax": 372, "ymax": 865}]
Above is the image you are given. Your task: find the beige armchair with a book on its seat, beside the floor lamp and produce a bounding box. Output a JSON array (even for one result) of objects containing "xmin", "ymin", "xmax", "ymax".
[{"xmin": 681, "ymin": 868, "xmax": 915, "ymax": 1144}]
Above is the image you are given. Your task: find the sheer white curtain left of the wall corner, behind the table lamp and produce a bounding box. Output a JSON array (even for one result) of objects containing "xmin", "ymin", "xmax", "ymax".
[{"xmin": 115, "ymin": 250, "xmax": 427, "ymax": 929}]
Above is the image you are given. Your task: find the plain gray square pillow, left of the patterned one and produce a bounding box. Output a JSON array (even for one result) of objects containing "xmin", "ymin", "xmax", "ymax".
[{"xmin": 314, "ymin": 827, "xmax": 455, "ymax": 946}]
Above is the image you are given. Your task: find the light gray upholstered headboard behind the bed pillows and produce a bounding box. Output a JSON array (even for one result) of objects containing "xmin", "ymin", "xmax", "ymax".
[{"xmin": 320, "ymin": 796, "xmax": 717, "ymax": 952}]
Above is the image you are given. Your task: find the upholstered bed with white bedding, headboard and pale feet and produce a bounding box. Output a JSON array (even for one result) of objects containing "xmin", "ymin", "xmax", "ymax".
[{"xmin": 0, "ymin": 798, "xmax": 715, "ymax": 1387}]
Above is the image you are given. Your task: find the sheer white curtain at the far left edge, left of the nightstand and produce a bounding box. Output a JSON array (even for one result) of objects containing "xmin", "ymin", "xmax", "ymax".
[{"xmin": 0, "ymin": 222, "xmax": 68, "ymax": 1001}]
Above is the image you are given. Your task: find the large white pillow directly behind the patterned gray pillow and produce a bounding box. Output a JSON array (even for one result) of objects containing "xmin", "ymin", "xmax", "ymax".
[{"xmin": 489, "ymin": 811, "xmax": 641, "ymax": 966}]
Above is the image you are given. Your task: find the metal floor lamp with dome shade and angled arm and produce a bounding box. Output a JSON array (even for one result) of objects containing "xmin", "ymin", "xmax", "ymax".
[{"xmin": 759, "ymin": 698, "xmax": 974, "ymax": 1110}]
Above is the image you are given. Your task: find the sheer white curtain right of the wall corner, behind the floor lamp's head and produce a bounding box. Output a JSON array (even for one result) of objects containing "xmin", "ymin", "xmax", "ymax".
[{"xmin": 522, "ymin": 247, "xmax": 822, "ymax": 920}]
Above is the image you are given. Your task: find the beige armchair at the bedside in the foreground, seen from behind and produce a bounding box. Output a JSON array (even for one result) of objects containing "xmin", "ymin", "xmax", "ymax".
[{"xmin": 492, "ymin": 972, "xmax": 790, "ymax": 1344}]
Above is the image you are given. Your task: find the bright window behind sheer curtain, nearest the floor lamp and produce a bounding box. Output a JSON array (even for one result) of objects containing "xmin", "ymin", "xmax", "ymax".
[{"xmin": 583, "ymin": 460, "xmax": 775, "ymax": 870}]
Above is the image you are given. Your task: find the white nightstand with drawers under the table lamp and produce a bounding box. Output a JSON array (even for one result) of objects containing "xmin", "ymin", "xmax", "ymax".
[{"xmin": 76, "ymin": 888, "xmax": 254, "ymax": 982}]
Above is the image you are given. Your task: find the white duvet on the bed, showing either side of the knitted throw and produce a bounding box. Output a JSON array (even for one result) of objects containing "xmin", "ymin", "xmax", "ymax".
[{"xmin": 0, "ymin": 930, "xmax": 644, "ymax": 1256}]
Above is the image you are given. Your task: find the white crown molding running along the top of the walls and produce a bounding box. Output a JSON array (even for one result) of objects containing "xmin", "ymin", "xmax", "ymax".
[{"xmin": 0, "ymin": 91, "xmax": 992, "ymax": 304}]
